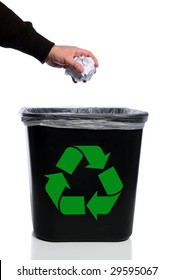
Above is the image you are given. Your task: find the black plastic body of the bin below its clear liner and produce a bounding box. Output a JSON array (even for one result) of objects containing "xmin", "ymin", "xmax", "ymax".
[{"xmin": 26, "ymin": 126, "xmax": 142, "ymax": 242}]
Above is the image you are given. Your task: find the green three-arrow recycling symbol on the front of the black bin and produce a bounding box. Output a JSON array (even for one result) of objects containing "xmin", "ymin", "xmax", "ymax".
[{"xmin": 45, "ymin": 146, "xmax": 123, "ymax": 220}]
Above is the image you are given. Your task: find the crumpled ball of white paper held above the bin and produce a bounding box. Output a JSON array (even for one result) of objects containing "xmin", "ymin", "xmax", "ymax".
[{"xmin": 65, "ymin": 56, "xmax": 95, "ymax": 83}]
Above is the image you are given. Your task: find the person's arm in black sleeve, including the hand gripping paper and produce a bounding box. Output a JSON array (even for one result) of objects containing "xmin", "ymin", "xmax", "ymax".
[{"xmin": 0, "ymin": 2, "xmax": 98, "ymax": 72}]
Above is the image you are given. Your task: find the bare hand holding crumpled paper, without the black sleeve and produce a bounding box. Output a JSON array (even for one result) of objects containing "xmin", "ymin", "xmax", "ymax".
[{"xmin": 46, "ymin": 45, "xmax": 99, "ymax": 73}]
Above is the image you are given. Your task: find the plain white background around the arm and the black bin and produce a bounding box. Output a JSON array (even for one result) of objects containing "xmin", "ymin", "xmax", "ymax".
[{"xmin": 0, "ymin": 0, "xmax": 173, "ymax": 279}]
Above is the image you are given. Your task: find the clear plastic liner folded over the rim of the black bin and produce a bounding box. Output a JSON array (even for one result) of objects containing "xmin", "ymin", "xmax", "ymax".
[{"xmin": 20, "ymin": 107, "xmax": 148, "ymax": 130}]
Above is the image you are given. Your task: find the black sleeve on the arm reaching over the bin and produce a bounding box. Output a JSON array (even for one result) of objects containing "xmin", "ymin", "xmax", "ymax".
[{"xmin": 0, "ymin": 2, "xmax": 54, "ymax": 63}]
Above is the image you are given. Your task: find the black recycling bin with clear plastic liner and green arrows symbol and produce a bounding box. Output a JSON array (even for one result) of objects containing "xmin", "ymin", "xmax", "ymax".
[{"xmin": 21, "ymin": 108, "xmax": 148, "ymax": 241}]
